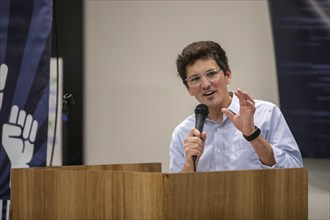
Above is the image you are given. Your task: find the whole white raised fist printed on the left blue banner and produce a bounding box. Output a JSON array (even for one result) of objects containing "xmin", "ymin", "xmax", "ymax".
[{"xmin": 2, "ymin": 105, "xmax": 38, "ymax": 168}]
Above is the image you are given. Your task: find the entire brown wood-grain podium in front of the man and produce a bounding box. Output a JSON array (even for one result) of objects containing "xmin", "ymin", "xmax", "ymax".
[{"xmin": 10, "ymin": 163, "xmax": 308, "ymax": 220}]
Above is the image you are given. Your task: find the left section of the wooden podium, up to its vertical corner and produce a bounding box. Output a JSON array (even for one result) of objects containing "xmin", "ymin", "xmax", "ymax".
[{"xmin": 10, "ymin": 163, "xmax": 162, "ymax": 220}]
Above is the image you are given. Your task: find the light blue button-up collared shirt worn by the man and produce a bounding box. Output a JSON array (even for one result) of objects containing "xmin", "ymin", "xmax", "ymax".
[{"xmin": 170, "ymin": 94, "xmax": 303, "ymax": 172}]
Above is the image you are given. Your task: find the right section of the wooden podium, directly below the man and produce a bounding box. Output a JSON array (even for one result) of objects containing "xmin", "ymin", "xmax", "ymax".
[{"xmin": 164, "ymin": 169, "xmax": 308, "ymax": 220}]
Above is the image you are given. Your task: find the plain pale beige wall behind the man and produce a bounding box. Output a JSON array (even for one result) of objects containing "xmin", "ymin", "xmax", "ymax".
[{"xmin": 84, "ymin": 1, "xmax": 329, "ymax": 218}]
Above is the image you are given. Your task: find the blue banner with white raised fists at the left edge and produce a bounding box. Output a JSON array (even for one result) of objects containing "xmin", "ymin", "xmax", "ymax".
[{"xmin": 0, "ymin": 0, "xmax": 52, "ymax": 219}]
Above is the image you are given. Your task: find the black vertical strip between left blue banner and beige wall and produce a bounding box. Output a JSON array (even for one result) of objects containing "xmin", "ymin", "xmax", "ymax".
[{"xmin": 52, "ymin": 0, "xmax": 84, "ymax": 165}]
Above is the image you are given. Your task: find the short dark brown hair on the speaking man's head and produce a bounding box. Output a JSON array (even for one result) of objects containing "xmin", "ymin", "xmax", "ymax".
[{"xmin": 176, "ymin": 41, "xmax": 228, "ymax": 87}]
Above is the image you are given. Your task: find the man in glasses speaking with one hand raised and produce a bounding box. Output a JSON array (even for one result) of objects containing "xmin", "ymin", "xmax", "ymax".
[{"xmin": 170, "ymin": 41, "xmax": 303, "ymax": 172}]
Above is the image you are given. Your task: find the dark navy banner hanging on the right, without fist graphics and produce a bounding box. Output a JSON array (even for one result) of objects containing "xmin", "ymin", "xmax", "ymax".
[{"xmin": 269, "ymin": 0, "xmax": 330, "ymax": 158}]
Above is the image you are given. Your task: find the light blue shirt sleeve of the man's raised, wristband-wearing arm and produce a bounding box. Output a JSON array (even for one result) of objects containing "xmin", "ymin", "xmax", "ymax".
[{"xmin": 263, "ymin": 106, "xmax": 303, "ymax": 168}]
